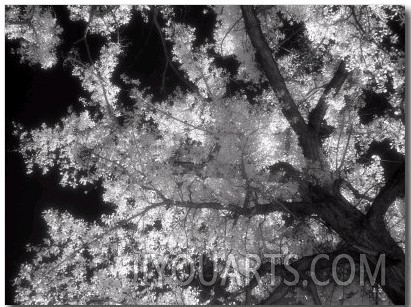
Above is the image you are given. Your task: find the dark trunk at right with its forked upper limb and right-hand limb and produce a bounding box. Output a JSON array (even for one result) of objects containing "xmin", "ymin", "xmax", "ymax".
[{"xmin": 241, "ymin": 6, "xmax": 405, "ymax": 304}]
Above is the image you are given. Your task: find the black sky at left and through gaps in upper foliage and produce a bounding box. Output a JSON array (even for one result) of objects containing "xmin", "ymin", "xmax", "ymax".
[{"xmin": 5, "ymin": 6, "xmax": 403, "ymax": 304}]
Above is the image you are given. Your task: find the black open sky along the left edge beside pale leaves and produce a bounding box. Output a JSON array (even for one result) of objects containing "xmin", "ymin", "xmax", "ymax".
[{"xmin": 5, "ymin": 25, "xmax": 111, "ymax": 304}]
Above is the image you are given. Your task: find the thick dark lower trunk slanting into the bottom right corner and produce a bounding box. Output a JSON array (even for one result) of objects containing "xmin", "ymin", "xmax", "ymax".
[{"xmin": 316, "ymin": 188, "xmax": 405, "ymax": 305}]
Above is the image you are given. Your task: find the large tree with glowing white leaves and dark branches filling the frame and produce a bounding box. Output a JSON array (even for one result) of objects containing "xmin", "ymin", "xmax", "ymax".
[{"xmin": 6, "ymin": 6, "xmax": 405, "ymax": 304}]
